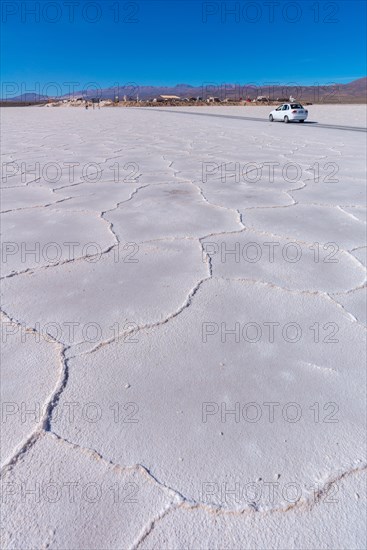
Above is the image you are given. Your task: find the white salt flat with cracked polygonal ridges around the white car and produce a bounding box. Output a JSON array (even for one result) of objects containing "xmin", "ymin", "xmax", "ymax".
[{"xmin": 1, "ymin": 105, "xmax": 367, "ymax": 550}]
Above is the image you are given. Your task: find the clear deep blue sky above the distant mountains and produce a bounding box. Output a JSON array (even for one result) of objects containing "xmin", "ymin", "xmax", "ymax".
[{"xmin": 1, "ymin": 0, "xmax": 366, "ymax": 95}]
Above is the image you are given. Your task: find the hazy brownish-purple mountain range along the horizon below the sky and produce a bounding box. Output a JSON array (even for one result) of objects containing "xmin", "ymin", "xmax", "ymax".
[{"xmin": 1, "ymin": 77, "xmax": 367, "ymax": 103}]
